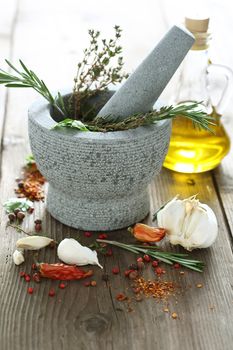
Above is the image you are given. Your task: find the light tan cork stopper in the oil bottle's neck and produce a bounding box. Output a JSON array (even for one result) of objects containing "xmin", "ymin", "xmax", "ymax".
[{"xmin": 185, "ymin": 17, "xmax": 210, "ymax": 50}]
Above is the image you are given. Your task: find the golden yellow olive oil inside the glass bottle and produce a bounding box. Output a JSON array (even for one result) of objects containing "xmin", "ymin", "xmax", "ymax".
[{"xmin": 164, "ymin": 112, "xmax": 230, "ymax": 173}]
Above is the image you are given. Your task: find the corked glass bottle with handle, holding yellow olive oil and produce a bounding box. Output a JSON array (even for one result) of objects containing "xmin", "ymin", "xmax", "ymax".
[{"xmin": 164, "ymin": 18, "xmax": 233, "ymax": 173}]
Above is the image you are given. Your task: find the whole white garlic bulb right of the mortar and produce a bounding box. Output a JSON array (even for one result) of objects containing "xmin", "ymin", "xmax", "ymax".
[{"xmin": 157, "ymin": 196, "xmax": 218, "ymax": 251}]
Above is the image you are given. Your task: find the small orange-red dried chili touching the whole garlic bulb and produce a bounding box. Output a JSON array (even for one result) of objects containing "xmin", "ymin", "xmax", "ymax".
[{"xmin": 130, "ymin": 224, "xmax": 166, "ymax": 242}]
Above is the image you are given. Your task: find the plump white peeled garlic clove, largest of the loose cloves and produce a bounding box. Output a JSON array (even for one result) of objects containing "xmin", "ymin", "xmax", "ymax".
[{"xmin": 57, "ymin": 238, "xmax": 103, "ymax": 269}]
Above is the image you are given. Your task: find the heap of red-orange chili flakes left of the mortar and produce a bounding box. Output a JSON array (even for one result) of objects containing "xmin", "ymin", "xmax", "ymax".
[{"xmin": 15, "ymin": 163, "xmax": 46, "ymax": 201}]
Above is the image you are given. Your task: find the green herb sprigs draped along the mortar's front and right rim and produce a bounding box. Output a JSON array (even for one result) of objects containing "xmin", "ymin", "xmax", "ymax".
[{"xmin": 55, "ymin": 102, "xmax": 215, "ymax": 132}]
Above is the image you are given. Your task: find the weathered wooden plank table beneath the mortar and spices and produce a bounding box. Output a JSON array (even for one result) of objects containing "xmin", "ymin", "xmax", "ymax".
[{"xmin": 0, "ymin": 0, "xmax": 233, "ymax": 350}]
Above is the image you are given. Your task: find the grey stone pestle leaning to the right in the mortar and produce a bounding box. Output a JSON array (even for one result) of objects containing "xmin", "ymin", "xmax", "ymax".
[{"xmin": 97, "ymin": 26, "xmax": 194, "ymax": 120}]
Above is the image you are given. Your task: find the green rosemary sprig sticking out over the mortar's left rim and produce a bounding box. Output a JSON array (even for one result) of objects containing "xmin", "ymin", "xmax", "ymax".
[{"xmin": 0, "ymin": 60, "xmax": 67, "ymax": 117}]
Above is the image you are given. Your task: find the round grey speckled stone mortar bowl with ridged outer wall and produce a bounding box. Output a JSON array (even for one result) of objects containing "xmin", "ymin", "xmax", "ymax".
[{"xmin": 29, "ymin": 99, "xmax": 171, "ymax": 230}]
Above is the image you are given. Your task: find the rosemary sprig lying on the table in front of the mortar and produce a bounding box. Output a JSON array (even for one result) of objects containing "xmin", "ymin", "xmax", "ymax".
[{"xmin": 96, "ymin": 239, "xmax": 204, "ymax": 272}]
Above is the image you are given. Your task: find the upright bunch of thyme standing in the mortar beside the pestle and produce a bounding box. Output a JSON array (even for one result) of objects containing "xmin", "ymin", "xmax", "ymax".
[{"xmin": 71, "ymin": 25, "xmax": 128, "ymax": 119}]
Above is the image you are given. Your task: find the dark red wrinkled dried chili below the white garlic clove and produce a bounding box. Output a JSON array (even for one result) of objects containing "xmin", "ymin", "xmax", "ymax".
[{"xmin": 38, "ymin": 263, "xmax": 93, "ymax": 281}]
